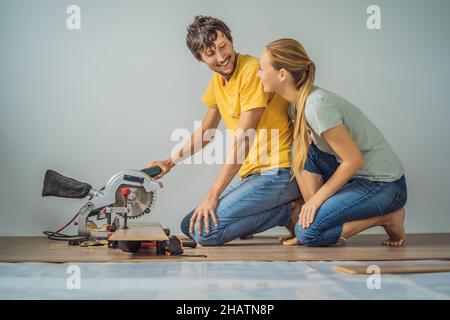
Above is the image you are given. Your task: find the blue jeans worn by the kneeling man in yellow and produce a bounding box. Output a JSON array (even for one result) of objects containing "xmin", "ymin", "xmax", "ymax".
[{"xmin": 181, "ymin": 168, "xmax": 300, "ymax": 246}]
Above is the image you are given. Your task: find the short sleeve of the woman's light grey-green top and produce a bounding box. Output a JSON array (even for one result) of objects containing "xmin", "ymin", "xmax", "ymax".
[{"xmin": 305, "ymin": 97, "xmax": 344, "ymax": 136}]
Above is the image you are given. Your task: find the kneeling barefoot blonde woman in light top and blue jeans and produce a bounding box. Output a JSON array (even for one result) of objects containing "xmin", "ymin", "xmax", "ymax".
[{"xmin": 259, "ymin": 39, "xmax": 407, "ymax": 246}]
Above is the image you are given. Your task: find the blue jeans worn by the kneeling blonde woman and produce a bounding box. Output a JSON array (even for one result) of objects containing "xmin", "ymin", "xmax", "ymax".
[{"xmin": 295, "ymin": 143, "xmax": 407, "ymax": 247}]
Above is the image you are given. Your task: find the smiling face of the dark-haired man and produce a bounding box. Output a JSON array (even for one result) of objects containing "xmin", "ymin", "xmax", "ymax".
[{"xmin": 201, "ymin": 32, "xmax": 236, "ymax": 78}]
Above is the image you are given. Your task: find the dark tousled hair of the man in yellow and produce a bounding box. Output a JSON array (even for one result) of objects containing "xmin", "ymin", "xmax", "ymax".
[{"xmin": 186, "ymin": 16, "xmax": 233, "ymax": 61}]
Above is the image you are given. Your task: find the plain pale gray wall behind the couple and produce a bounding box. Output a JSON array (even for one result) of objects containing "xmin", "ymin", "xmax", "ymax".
[{"xmin": 0, "ymin": 0, "xmax": 450, "ymax": 235}]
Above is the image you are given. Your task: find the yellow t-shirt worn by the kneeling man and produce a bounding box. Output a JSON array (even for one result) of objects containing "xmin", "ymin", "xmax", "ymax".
[{"xmin": 202, "ymin": 54, "xmax": 293, "ymax": 178}]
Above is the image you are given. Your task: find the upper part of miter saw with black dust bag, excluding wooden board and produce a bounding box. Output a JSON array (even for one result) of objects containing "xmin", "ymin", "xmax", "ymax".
[{"xmin": 42, "ymin": 167, "xmax": 163, "ymax": 238}]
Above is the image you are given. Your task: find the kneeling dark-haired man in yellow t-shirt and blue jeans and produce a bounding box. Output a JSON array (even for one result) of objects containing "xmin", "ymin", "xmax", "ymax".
[{"xmin": 148, "ymin": 16, "xmax": 300, "ymax": 245}]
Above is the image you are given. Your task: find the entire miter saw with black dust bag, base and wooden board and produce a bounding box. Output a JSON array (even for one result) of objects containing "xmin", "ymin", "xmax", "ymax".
[{"xmin": 42, "ymin": 167, "xmax": 197, "ymax": 255}]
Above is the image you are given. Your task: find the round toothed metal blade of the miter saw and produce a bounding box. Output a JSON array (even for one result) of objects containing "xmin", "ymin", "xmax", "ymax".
[{"xmin": 114, "ymin": 186, "xmax": 156, "ymax": 219}]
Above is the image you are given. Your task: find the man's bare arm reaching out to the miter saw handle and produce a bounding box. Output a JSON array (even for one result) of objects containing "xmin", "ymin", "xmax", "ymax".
[{"xmin": 147, "ymin": 108, "xmax": 222, "ymax": 179}]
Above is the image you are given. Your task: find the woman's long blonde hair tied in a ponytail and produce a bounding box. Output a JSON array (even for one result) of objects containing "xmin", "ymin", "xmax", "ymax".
[{"xmin": 266, "ymin": 39, "xmax": 316, "ymax": 178}]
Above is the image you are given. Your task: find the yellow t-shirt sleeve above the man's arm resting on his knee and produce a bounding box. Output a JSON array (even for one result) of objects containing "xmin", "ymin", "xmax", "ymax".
[{"xmin": 239, "ymin": 64, "xmax": 267, "ymax": 112}]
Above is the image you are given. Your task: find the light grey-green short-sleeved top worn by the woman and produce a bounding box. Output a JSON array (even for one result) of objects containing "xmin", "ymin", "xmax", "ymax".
[{"xmin": 305, "ymin": 86, "xmax": 405, "ymax": 182}]
